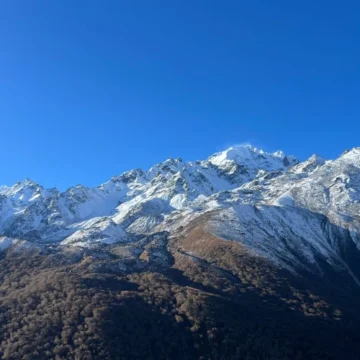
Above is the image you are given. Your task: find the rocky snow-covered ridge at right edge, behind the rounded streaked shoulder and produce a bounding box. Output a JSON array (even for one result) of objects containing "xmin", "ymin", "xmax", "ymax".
[{"xmin": 231, "ymin": 148, "xmax": 360, "ymax": 231}]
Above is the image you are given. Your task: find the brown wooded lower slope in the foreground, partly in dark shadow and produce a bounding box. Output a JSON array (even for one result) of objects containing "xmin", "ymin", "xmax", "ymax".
[{"xmin": 0, "ymin": 239, "xmax": 360, "ymax": 360}]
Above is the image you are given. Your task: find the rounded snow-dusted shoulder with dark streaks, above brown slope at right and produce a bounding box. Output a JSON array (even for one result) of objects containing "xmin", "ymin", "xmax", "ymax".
[{"xmin": 156, "ymin": 201, "xmax": 360, "ymax": 285}]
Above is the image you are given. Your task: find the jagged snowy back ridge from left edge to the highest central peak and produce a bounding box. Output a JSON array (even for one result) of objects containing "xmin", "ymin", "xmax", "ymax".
[{"xmin": 0, "ymin": 146, "xmax": 297, "ymax": 242}]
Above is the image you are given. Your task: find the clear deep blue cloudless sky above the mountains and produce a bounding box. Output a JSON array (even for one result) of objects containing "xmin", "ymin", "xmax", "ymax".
[{"xmin": 0, "ymin": 0, "xmax": 360, "ymax": 189}]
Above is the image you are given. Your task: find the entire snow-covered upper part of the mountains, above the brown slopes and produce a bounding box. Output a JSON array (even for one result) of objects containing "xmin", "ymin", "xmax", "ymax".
[{"xmin": 0, "ymin": 145, "xmax": 360, "ymax": 284}]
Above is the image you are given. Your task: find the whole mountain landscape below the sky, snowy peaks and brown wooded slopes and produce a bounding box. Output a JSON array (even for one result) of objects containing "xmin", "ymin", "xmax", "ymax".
[{"xmin": 0, "ymin": 146, "xmax": 360, "ymax": 360}]
